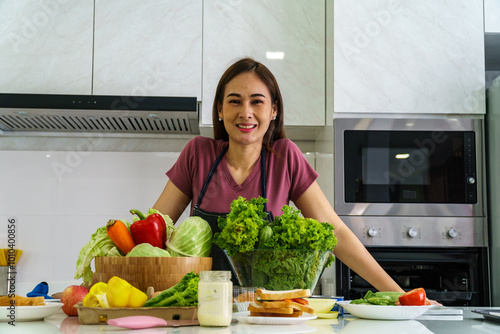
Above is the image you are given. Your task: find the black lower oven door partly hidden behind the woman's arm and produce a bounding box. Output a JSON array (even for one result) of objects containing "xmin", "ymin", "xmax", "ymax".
[{"xmin": 335, "ymin": 247, "xmax": 490, "ymax": 306}]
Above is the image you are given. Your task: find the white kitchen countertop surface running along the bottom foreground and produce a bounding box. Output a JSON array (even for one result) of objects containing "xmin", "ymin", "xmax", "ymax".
[{"xmin": 0, "ymin": 307, "xmax": 500, "ymax": 334}]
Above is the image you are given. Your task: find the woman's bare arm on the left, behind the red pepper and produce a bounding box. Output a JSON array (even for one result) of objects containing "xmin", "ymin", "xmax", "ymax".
[{"xmin": 153, "ymin": 180, "xmax": 191, "ymax": 224}]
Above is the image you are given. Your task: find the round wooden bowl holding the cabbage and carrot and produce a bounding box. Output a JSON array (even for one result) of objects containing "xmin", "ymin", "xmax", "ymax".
[{"xmin": 95, "ymin": 256, "xmax": 212, "ymax": 291}]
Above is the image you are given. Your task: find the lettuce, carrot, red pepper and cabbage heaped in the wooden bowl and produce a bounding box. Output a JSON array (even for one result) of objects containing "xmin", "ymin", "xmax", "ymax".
[{"xmin": 75, "ymin": 209, "xmax": 212, "ymax": 283}]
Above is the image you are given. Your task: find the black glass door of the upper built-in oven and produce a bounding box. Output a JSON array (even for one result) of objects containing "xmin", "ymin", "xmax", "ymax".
[{"xmin": 344, "ymin": 130, "xmax": 477, "ymax": 204}]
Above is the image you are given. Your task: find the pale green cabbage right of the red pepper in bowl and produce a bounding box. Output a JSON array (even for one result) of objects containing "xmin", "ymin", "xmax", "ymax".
[{"xmin": 167, "ymin": 217, "xmax": 212, "ymax": 257}]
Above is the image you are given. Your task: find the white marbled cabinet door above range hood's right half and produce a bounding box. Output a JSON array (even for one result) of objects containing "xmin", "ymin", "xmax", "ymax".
[{"xmin": 93, "ymin": 0, "xmax": 203, "ymax": 100}]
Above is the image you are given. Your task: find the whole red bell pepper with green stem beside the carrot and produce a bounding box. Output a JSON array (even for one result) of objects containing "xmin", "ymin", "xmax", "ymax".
[{"xmin": 130, "ymin": 209, "xmax": 167, "ymax": 249}]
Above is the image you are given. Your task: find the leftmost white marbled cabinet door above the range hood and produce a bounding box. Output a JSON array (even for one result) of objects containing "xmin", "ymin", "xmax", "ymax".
[{"xmin": 0, "ymin": 0, "xmax": 93, "ymax": 94}]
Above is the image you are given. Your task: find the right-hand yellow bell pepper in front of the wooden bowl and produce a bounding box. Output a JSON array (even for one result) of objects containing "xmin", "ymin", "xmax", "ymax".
[{"xmin": 106, "ymin": 276, "xmax": 148, "ymax": 307}]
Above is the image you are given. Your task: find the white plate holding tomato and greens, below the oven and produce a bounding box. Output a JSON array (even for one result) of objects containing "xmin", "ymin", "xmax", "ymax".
[{"xmin": 337, "ymin": 300, "xmax": 435, "ymax": 320}]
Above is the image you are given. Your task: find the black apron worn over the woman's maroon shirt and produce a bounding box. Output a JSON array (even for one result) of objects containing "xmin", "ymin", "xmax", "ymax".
[{"xmin": 193, "ymin": 145, "xmax": 273, "ymax": 285}]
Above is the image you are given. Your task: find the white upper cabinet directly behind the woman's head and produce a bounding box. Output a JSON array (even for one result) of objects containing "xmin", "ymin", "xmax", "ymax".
[{"xmin": 202, "ymin": 0, "xmax": 325, "ymax": 126}]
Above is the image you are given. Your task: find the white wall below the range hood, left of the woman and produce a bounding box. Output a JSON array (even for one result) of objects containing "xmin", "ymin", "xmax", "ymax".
[{"xmin": 0, "ymin": 151, "xmax": 182, "ymax": 295}]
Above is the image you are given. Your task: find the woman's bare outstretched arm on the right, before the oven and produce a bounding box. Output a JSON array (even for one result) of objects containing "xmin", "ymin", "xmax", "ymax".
[{"xmin": 295, "ymin": 181, "xmax": 404, "ymax": 292}]
